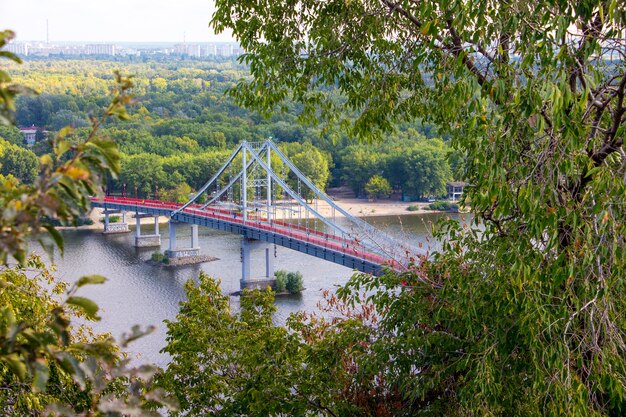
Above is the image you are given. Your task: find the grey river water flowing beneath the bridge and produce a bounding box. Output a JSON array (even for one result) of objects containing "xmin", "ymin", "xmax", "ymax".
[{"xmin": 45, "ymin": 213, "xmax": 458, "ymax": 366}]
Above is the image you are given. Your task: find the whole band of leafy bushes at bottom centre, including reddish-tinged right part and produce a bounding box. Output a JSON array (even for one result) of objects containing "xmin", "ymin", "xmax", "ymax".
[{"xmin": 160, "ymin": 274, "xmax": 419, "ymax": 417}]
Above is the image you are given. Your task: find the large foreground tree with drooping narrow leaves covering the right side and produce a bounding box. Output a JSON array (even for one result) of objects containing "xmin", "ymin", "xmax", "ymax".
[{"xmin": 212, "ymin": 0, "xmax": 626, "ymax": 416}]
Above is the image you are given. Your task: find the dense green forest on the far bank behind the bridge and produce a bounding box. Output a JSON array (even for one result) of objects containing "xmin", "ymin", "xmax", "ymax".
[{"xmin": 0, "ymin": 59, "xmax": 459, "ymax": 200}]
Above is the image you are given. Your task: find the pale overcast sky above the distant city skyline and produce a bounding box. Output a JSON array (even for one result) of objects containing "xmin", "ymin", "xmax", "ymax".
[{"xmin": 0, "ymin": 0, "xmax": 232, "ymax": 42}]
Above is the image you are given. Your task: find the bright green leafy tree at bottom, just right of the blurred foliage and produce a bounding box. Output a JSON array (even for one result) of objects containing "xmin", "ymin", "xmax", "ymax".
[{"xmin": 162, "ymin": 274, "xmax": 298, "ymax": 416}]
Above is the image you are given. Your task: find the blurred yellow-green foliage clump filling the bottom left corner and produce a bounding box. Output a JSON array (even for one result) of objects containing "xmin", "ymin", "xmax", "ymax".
[{"xmin": 0, "ymin": 257, "xmax": 169, "ymax": 417}]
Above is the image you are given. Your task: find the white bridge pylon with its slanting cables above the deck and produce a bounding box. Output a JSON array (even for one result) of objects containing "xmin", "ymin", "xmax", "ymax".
[{"xmin": 172, "ymin": 140, "xmax": 416, "ymax": 268}]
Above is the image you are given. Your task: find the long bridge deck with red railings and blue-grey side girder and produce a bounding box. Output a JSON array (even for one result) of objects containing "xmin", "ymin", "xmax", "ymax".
[{"xmin": 92, "ymin": 197, "xmax": 398, "ymax": 275}]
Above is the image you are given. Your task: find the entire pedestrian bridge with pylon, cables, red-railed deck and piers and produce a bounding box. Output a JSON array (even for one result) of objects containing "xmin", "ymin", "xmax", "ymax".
[{"xmin": 91, "ymin": 141, "xmax": 416, "ymax": 287}]
